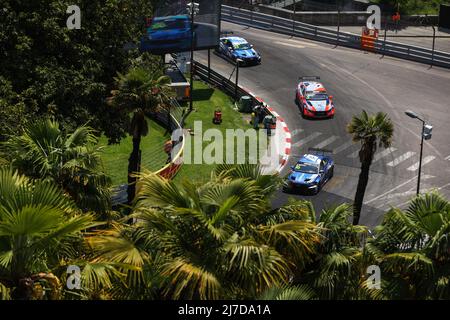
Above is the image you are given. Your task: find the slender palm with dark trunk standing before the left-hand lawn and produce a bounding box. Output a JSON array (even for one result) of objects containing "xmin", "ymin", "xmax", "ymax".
[{"xmin": 109, "ymin": 67, "xmax": 173, "ymax": 204}]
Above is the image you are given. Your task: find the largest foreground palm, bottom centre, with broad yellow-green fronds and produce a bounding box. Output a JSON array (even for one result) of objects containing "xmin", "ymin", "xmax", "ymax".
[{"xmin": 90, "ymin": 165, "xmax": 319, "ymax": 299}]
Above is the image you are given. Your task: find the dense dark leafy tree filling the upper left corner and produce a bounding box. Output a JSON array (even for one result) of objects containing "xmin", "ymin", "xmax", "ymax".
[{"xmin": 0, "ymin": 0, "xmax": 156, "ymax": 142}]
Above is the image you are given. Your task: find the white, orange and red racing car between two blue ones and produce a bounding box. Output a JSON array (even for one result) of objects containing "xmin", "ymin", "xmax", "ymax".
[{"xmin": 295, "ymin": 77, "xmax": 335, "ymax": 118}]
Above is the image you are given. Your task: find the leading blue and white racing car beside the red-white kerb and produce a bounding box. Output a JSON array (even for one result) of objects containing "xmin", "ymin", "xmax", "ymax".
[{"xmin": 283, "ymin": 148, "xmax": 334, "ymax": 194}]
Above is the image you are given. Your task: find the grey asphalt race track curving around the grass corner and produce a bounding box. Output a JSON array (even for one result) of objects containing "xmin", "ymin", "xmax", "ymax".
[{"xmin": 195, "ymin": 22, "xmax": 450, "ymax": 227}]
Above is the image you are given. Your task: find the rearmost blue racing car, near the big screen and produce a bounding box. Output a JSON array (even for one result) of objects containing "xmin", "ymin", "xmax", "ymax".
[{"xmin": 216, "ymin": 36, "xmax": 261, "ymax": 65}]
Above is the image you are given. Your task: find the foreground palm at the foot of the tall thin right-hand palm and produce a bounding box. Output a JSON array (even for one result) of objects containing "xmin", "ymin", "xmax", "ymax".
[{"xmin": 294, "ymin": 202, "xmax": 368, "ymax": 300}]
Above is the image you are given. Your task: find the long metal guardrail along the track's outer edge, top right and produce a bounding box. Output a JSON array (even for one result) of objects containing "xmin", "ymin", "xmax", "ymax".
[{"xmin": 221, "ymin": 5, "xmax": 450, "ymax": 68}]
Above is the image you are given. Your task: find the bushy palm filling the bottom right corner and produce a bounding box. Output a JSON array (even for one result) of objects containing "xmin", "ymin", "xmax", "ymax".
[{"xmin": 365, "ymin": 192, "xmax": 450, "ymax": 300}]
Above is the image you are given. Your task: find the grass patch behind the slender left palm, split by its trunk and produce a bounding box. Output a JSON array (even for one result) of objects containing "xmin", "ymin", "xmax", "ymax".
[{"xmin": 99, "ymin": 119, "xmax": 170, "ymax": 186}]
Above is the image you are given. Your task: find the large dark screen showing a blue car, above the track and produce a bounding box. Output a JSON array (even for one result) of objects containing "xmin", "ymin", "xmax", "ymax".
[{"xmin": 140, "ymin": 0, "xmax": 221, "ymax": 54}]
